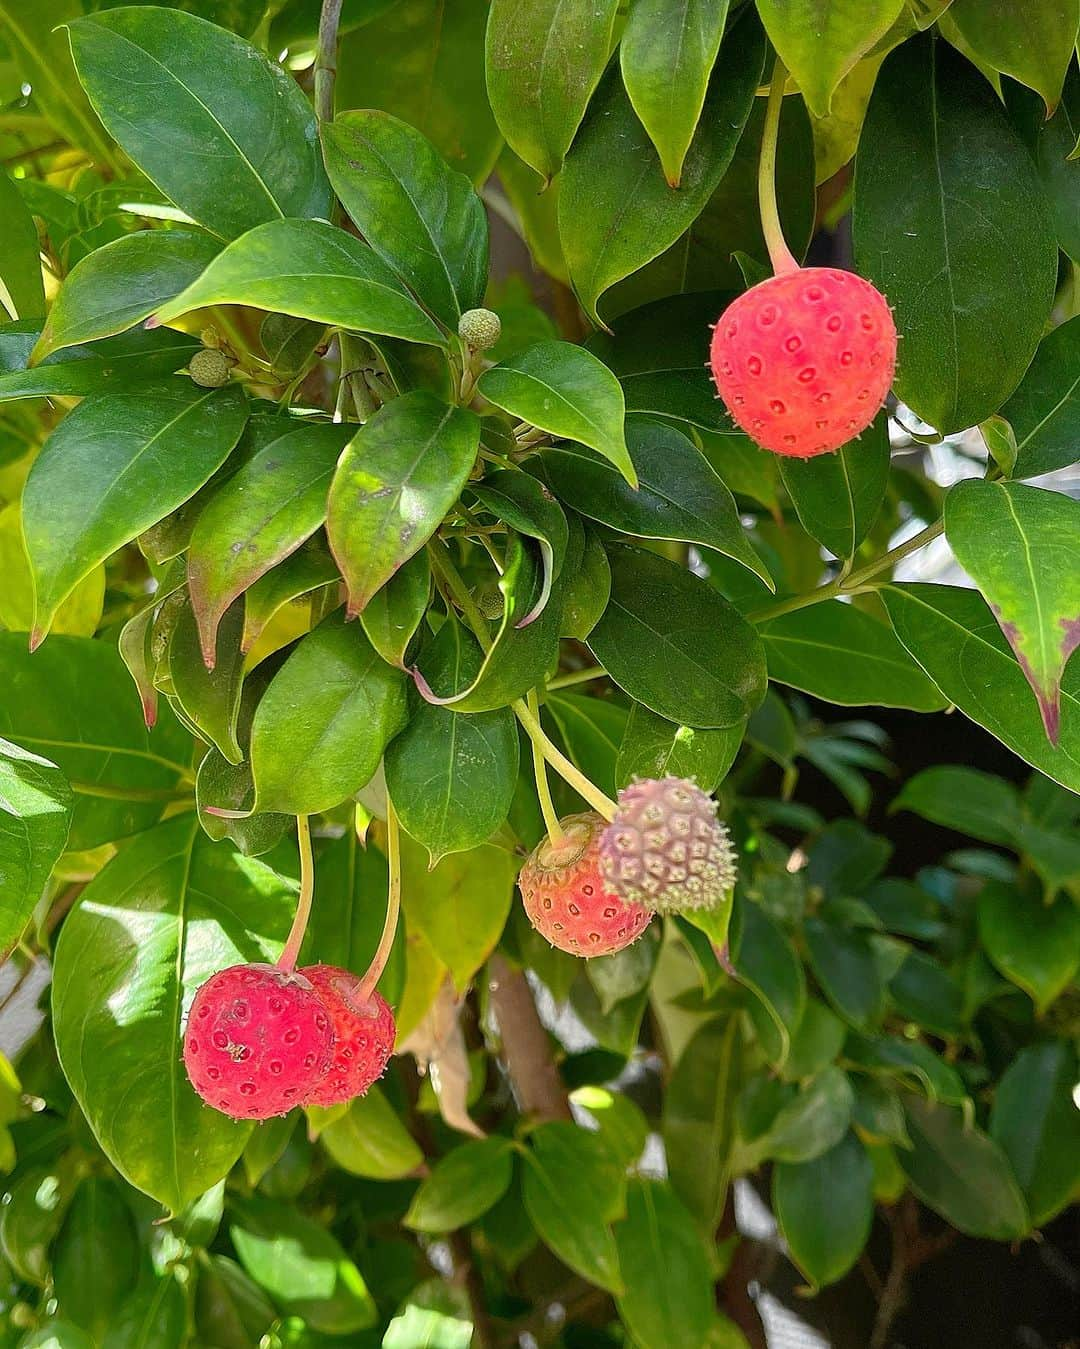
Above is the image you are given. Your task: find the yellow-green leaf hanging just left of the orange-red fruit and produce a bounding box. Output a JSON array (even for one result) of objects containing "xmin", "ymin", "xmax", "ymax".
[{"xmin": 402, "ymin": 830, "xmax": 516, "ymax": 992}]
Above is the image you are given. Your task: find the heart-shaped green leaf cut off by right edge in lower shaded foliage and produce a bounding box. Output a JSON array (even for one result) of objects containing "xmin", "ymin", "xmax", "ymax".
[{"xmin": 979, "ymin": 881, "xmax": 1080, "ymax": 1016}]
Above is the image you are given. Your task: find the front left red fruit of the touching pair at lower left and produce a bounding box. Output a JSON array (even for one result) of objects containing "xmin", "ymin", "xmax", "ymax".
[{"xmin": 183, "ymin": 965, "xmax": 333, "ymax": 1120}]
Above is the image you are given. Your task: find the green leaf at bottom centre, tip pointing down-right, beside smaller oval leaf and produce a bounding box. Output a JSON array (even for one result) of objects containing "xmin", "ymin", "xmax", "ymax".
[{"xmin": 522, "ymin": 1120, "xmax": 626, "ymax": 1294}]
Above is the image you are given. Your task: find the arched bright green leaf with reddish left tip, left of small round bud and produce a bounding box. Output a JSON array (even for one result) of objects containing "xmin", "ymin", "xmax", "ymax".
[{"xmin": 155, "ymin": 220, "xmax": 446, "ymax": 347}]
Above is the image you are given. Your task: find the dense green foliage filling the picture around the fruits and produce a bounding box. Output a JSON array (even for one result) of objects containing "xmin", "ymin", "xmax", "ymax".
[{"xmin": 0, "ymin": 0, "xmax": 1080, "ymax": 1349}]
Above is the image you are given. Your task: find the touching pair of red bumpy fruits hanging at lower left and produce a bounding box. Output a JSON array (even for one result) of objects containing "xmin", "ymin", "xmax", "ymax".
[{"xmin": 183, "ymin": 965, "xmax": 396, "ymax": 1120}]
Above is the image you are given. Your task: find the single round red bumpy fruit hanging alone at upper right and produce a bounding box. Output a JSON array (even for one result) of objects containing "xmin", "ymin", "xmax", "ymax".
[{"xmin": 709, "ymin": 267, "xmax": 897, "ymax": 459}]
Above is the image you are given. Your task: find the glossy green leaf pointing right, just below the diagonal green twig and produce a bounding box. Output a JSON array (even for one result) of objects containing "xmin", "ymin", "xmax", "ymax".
[{"xmin": 758, "ymin": 599, "xmax": 947, "ymax": 712}]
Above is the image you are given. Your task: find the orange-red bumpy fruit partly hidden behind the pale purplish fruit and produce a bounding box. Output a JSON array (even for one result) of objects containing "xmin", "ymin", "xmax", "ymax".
[{"xmin": 518, "ymin": 811, "xmax": 653, "ymax": 956}]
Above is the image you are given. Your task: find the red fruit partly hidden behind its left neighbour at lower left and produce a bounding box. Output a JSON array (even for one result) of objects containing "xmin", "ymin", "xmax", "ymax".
[{"xmin": 299, "ymin": 965, "xmax": 398, "ymax": 1106}]
